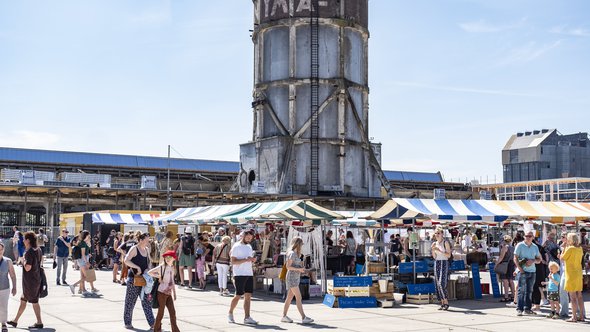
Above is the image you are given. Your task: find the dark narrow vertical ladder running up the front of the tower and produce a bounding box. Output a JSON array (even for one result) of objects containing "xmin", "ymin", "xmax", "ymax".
[{"xmin": 309, "ymin": 0, "xmax": 320, "ymax": 196}]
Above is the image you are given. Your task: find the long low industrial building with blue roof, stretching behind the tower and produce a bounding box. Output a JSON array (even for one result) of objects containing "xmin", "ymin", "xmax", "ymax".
[{"xmin": 0, "ymin": 147, "xmax": 471, "ymax": 226}]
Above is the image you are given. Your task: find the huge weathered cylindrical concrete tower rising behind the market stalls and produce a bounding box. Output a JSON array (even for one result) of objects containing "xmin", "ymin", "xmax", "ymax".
[{"xmin": 239, "ymin": 0, "xmax": 383, "ymax": 197}]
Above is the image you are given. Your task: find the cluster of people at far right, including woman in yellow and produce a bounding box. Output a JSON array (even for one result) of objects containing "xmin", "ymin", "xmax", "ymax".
[{"xmin": 496, "ymin": 231, "xmax": 587, "ymax": 322}]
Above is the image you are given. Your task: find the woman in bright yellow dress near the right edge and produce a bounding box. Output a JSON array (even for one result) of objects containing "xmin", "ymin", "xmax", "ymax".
[{"xmin": 561, "ymin": 233, "xmax": 586, "ymax": 322}]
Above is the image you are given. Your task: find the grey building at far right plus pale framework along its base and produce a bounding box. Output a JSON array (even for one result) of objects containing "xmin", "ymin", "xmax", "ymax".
[{"xmin": 474, "ymin": 129, "xmax": 590, "ymax": 202}]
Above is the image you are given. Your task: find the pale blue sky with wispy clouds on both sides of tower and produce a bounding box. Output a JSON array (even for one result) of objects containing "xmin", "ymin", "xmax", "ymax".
[{"xmin": 0, "ymin": 0, "xmax": 590, "ymax": 182}]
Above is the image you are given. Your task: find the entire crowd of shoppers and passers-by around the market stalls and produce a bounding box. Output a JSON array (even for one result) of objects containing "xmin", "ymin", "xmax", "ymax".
[{"xmin": 0, "ymin": 223, "xmax": 588, "ymax": 331}]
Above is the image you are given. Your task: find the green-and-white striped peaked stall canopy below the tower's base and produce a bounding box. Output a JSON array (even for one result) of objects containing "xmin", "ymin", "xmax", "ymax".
[{"xmin": 218, "ymin": 200, "xmax": 344, "ymax": 224}]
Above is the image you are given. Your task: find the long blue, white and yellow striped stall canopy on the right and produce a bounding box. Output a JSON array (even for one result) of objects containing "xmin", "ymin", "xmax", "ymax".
[{"xmin": 366, "ymin": 198, "xmax": 590, "ymax": 223}]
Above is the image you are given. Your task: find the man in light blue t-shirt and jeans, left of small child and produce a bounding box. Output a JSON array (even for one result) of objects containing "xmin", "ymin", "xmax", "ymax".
[{"xmin": 514, "ymin": 231, "xmax": 541, "ymax": 316}]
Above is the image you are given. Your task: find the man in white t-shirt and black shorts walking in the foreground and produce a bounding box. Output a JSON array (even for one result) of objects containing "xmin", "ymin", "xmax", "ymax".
[{"xmin": 227, "ymin": 230, "xmax": 258, "ymax": 325}]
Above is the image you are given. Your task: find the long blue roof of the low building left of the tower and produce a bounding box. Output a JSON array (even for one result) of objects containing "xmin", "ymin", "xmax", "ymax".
[{"xmin": 0, "ymin": 147, "xmax": 240, "ymax": 173}]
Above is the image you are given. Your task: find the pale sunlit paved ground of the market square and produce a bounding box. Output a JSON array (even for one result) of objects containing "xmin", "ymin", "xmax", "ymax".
[{"xmin": 9, "ymin": 264, "xmax": 590, "ymax": 332}]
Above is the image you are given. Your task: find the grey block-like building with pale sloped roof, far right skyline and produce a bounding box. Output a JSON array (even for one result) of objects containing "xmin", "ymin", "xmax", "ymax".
[{"xmin": 502, "ymin": 129, "xmax": 590, "ymax": 183}]
